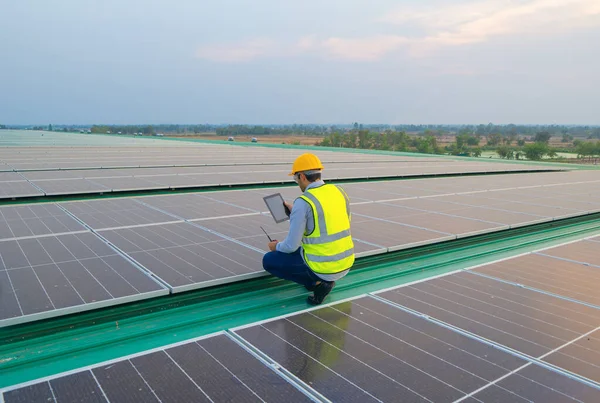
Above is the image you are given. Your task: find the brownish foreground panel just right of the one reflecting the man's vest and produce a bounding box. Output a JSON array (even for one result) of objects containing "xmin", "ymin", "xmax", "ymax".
[{"xmin": 381, "ymin": 273, "xmax": 600, "ymax": 357}]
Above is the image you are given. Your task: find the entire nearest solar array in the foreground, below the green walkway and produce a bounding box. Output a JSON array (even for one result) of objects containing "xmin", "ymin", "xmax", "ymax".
[{"xmin": 3, "ymin": 238, "xmax": 600, "ymax": 403}]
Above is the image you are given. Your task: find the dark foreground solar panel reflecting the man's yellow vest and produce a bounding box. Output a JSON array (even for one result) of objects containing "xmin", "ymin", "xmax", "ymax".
[{"xmin": 234, "ymin": 297, "xmax": 600, "ymax": 402}]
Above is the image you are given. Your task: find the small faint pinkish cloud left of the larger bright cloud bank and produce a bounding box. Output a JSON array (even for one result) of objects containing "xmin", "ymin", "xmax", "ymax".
[{"xmin": 196, "ymin": 39, "xmax": 276, "ymax": 63}]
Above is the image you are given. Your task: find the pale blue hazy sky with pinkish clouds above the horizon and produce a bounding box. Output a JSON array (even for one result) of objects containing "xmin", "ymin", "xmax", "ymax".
[{"xmin": 0, "ymin": 0, "xmax": 600, "ymax": 124}]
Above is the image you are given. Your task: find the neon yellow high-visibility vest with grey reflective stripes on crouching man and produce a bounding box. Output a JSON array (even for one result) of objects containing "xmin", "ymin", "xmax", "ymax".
[{"xmin": 300, "ymin": 185, "xmax": 354, "ymax": 274}]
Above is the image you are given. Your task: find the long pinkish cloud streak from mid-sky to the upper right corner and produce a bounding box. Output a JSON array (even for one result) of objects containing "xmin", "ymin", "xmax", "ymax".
[{"xmin": 197, "ymin": 0, "xmax": 600, "ymax": 62}]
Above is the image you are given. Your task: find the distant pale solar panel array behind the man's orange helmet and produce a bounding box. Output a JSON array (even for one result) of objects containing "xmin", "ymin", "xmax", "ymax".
[{"xmin": 0, "ymin": 131, "xmax": 558, "ymax": 200}]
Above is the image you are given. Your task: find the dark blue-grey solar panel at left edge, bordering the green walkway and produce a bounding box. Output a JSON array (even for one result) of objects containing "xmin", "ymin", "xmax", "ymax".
[{"xmin": 0, "ymin": 232, "xmax": 168, "ymax": 327}]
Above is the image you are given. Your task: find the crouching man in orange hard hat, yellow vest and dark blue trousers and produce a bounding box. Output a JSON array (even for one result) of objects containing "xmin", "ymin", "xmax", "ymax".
[{"xmin": 263, "ymin": 153, "xmax": 354, "ymax": 305}]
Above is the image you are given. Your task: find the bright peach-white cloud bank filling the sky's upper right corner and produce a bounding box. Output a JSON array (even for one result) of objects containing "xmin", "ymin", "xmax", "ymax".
[{"xmin": 314, "ymin": 0, "xmax": 600, "ymax": 61}]
